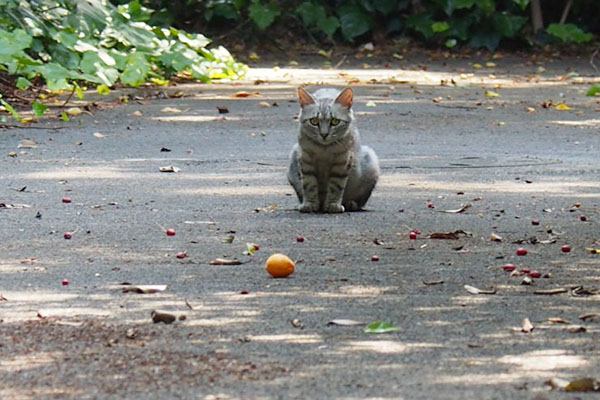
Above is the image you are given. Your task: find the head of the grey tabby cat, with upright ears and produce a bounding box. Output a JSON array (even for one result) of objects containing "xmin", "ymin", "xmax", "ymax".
[{"xmin": 298, "ymin": 88, "xmax": 354, "ymax": 144}]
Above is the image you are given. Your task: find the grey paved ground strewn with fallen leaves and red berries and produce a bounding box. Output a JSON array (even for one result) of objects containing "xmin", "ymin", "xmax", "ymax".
[{"xmin": 0, "ymin": 54, "xmax": 600, "ymax": 400}]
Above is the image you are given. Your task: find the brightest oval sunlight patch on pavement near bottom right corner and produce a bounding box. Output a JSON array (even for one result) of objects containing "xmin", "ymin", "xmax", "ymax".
[{"xmin": 498, "ymin": 349, "xmax": 589, "ymax": 372}]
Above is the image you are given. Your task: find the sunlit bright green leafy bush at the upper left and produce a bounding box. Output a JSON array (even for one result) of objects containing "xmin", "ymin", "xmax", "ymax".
[{"xmin": 0, "ymin": 0, "xmax": 246, "ymax": 97}]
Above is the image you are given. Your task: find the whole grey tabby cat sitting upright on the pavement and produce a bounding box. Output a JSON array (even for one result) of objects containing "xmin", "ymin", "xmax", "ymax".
[{"xmin": 288, "ymin": 87, "xmax": 379, "ymax": 213}]
